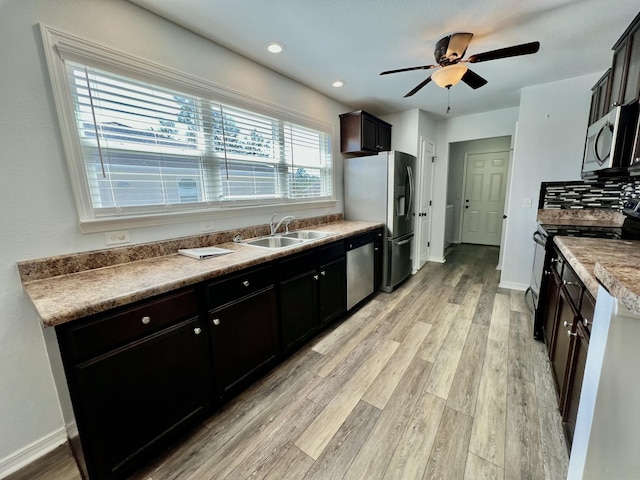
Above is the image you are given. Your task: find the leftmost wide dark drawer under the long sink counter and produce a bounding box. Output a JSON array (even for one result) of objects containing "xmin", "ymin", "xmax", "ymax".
[{"xmin": 58, "ymin": 290, "xmax": 198, "ymax": 362}]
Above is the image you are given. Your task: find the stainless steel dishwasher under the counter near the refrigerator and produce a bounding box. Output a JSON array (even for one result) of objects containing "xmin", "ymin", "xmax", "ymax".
[{"xmin": 346, "ymin": 232, "xmax": 374, "ymax": 310}]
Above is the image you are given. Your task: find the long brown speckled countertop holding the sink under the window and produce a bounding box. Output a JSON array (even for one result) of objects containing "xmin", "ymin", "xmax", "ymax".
[{"xmin": 23, "ymin": 221, "xmax": 383, "ymax": 327}]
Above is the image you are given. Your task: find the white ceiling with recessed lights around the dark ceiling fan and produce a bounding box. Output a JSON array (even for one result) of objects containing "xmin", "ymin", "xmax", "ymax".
[{"xmin": 130, "ymin": 0, "xmax": 638, "ymax": 116}]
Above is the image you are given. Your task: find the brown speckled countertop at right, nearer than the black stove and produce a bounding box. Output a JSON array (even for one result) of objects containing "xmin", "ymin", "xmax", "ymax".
[{"xmin": 554, "ymin": 236, "xmax": 640, "ymax": 315}]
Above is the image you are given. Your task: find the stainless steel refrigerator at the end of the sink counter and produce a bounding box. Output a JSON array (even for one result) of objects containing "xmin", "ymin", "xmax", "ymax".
[{"xmin": 344, "ymin": 151, "xmax": 416, "ymax": 292}]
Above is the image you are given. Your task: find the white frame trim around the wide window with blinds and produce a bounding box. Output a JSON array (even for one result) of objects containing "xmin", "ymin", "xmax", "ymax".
[{"xmin": 40, "ymin": 24, "xmax": 337, "ymax": 233}]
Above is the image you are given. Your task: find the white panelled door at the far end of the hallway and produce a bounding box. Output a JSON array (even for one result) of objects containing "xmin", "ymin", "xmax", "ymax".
[{"xmin": 462, "ymin": 151, "xmax": 509, "ymax": 245}]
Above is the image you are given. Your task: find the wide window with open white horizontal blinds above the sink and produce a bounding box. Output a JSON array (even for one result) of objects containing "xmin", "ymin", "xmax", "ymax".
[{"xmin": 43, "ymin": 27, "xmax": 333, "ymax": 230}]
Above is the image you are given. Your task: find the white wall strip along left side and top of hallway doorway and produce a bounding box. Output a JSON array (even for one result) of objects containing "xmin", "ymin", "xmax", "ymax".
[{"xmin": 431, "ymin": 108, "xmax": 518, "ymax": 261}]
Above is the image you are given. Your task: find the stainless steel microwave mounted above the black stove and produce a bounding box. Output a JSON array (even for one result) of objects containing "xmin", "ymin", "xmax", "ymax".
[{"xmin": 582, "ymin": 102, "xmax": 638, "ymax": 177}]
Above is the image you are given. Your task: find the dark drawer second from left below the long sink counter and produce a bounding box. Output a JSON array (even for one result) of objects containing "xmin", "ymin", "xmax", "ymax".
[{"xmin": 207, "ymin": 265, "xmax": 274, "ymax": 308}]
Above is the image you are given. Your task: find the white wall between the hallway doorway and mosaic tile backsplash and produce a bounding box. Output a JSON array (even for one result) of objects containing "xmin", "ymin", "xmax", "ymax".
[{"xmin": 500, "ymin": 74, "xmax": 600, "ymax": 289}]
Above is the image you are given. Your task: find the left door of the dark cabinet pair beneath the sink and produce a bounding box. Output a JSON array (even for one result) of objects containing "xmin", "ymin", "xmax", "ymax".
[{"xmin": 280, "ymin": 271, "xmax": 319, "ymax": 350}]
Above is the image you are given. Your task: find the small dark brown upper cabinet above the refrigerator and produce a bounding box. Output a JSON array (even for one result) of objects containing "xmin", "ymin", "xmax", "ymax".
[{"xmin": 340, "ymin": 110, "xmax": 391, "ymax": 156}]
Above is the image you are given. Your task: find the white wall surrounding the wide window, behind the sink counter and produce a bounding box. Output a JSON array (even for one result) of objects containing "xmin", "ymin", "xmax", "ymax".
[{"xmin": 0, "ymin": 0, "xmax": 350, "ymax": 476}]
